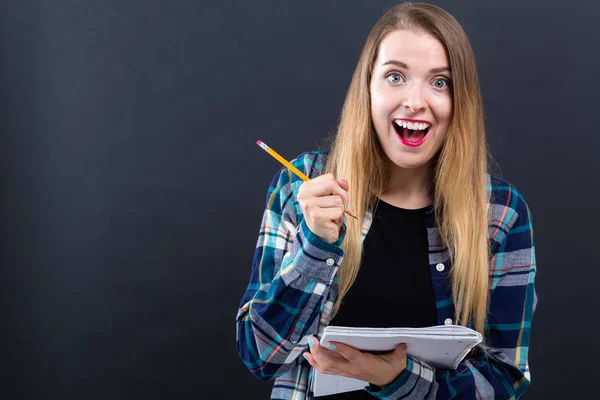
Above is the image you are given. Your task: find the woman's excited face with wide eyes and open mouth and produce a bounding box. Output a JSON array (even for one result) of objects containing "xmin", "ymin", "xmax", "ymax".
[{"xmin": 370, "ymin": 30, "xmax": 452, "ymax": 169}]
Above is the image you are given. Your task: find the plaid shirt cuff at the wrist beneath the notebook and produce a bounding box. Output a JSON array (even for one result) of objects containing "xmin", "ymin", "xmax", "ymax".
[{"xmin": 365, "ymin": 357, "xmax": 435, "ymax": 399}]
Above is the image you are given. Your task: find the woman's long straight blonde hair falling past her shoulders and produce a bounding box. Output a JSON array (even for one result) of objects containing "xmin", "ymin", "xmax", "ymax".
[{"xmin": 325, "ymin": 3, "xmax": 489, "ymax": 334}]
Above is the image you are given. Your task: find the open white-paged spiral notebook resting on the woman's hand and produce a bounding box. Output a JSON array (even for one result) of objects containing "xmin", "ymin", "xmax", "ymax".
[{"xmin": 313, "ymin": 325, "xmax": 483, "ymax": 396}]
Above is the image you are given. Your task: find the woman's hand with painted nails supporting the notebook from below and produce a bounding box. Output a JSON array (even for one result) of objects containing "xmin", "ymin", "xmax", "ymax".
[{"xmin": 304, "ymin": 336, "xmax": 406, "ymax": 386}]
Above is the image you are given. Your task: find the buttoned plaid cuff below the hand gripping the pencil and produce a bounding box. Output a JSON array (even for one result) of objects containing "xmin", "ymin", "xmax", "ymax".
[{"xmin": 291, "ymin": 220, "xmax": 346, "ymax": 284}]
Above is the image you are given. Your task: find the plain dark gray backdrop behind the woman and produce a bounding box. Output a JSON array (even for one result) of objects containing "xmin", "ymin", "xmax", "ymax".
[{"xmin": 0, "ymin": 0, "xmax": 600, "ymax": 399}]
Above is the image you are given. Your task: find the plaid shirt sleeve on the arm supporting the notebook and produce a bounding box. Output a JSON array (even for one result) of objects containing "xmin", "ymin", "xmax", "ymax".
[{"xmin": 367, "ymin": 189, "xmax": 537, "ymax": 400}]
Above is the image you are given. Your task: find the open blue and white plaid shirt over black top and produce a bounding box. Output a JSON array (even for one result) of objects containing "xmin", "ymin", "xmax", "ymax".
[{"xmin": 236, "ymin": 152, "xmax": 537, "ymax": 400}]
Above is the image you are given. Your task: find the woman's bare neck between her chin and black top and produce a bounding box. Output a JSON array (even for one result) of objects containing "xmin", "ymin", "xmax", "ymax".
[{"xmin": 379, "ymin": 165, "xmax": 433, "ymax": 210}]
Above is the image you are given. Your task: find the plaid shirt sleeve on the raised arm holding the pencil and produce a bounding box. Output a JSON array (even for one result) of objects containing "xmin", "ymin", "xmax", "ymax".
[{"xmin": 236, "ymin": 165, "xmax": 345, "ymax": 380}]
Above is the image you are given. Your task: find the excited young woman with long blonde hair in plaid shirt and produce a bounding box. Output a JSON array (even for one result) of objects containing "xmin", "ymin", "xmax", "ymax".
[{"xmin": 237, "ymin": 3, "xmax": 536, "ymax": 399}]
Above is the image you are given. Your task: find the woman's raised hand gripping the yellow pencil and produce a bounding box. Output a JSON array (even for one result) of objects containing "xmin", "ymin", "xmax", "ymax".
[{"xmin": 298, "ymin": 174, "xmax": 349, "ymax": 243}]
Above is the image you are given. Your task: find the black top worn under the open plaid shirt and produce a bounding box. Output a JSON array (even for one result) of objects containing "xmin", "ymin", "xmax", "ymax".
[{"xmin": 318, "ymin": 200, "xmax": 437, "ymax": 400}]
